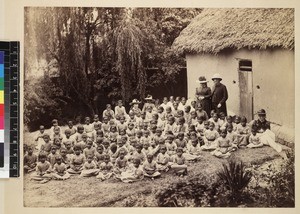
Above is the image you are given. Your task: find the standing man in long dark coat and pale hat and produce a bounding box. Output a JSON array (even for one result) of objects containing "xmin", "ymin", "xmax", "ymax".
[{"xmin": 211, "ymin": 73, "xmax": 228, "ymax": 116}]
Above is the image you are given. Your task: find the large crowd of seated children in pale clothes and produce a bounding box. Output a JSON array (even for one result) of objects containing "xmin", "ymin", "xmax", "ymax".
[{"xmin": 24, "ymin": 97, "xmax": 262, "ymax": 183}]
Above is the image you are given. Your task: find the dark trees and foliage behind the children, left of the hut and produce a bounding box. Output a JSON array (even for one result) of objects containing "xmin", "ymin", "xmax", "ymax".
[{"xmin": 24, "ymin": 7, "xmax": 201, "ymax": 130}]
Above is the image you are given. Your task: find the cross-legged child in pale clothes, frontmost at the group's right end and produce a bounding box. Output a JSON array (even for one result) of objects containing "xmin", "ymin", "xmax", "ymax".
[{"xmin": 211, "ymin": 130, "xmax": 234, "ymax": 158}]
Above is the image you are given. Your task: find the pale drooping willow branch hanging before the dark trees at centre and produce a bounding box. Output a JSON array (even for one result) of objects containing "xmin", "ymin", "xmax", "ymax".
[{"xmin": 113, "ymin": 14, "xmax": 146, "ymax": 101}]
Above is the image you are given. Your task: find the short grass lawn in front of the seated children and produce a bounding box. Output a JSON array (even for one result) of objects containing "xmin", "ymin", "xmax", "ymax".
[{"xmin": 24, "ymin": 142, "xmax": 281, "ymax": 207}]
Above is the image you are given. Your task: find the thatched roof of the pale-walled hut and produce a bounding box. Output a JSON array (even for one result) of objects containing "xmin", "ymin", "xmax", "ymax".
[{"xmin": 173, "ymin": 8, "xmax": 294, "ymax": 54}]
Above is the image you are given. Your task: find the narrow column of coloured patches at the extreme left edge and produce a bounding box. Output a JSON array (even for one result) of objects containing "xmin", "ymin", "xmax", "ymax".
[{"xmin": 0, "ymin": 51, "xmax": 4, "ymax": 167}]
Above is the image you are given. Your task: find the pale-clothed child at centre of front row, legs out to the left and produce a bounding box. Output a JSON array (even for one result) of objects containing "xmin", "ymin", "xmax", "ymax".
[{"xmin": 119, "ymin": 158, "xmax": 144, "ymax": 183}]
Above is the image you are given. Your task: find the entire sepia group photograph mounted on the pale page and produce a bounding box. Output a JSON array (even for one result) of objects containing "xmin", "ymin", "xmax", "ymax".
[{"xmin": 21, "ymin": 6, "xmax": 295, "ymax": 208}]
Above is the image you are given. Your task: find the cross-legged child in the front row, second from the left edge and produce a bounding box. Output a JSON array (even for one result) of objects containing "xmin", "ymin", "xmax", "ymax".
[{"xmin": 31, "ymin": 152, "xmax": 52, "ymax": 184}]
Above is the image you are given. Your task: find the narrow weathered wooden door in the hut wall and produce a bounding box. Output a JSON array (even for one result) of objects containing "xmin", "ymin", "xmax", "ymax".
[{"xmin": 238, "ymin": 60, "xmax": 253, "ymax": 122}]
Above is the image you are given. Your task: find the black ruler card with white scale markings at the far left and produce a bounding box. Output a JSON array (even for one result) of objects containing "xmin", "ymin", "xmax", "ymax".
[{"xmin": 0, "ymin": 42, "xmax": 20, "ymax": 178}]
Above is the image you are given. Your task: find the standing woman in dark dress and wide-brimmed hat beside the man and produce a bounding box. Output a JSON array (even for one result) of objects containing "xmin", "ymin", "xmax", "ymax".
[{"xmin": 196, "ymin": 76, "xmax": 211, "ymax": 115}]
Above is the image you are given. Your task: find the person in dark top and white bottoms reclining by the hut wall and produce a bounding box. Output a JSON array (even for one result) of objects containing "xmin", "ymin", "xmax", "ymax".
[{"xmin": 251, "ymin": 109, "xmax": 286, "ymax": 158}]
